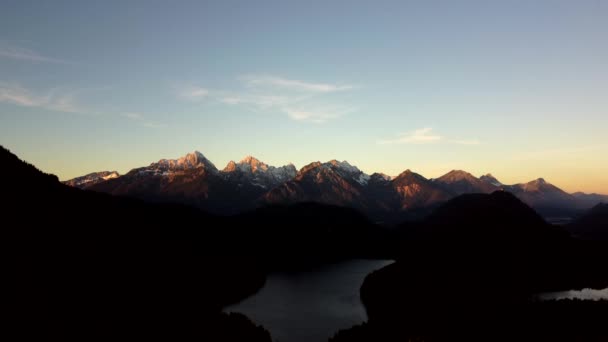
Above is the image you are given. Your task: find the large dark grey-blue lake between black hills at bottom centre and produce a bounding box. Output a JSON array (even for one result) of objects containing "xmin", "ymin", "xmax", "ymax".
[{"xmin": 224, "ymin": 260, "xmax": 393, "ymax": 342}]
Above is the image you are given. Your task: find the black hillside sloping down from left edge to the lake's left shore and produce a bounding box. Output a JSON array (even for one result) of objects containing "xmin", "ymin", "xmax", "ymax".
[{"xmin": 0, "ymin": 148, "xmax": 270, "ymax": 341}]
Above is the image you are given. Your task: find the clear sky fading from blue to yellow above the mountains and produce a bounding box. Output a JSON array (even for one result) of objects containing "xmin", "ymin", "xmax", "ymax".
[{"xmin": 0, "ymin": 0, "xmax": 608, "ymax": 194}]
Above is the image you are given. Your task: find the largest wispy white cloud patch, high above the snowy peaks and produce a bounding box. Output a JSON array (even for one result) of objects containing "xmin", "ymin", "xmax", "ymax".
[{"xmin": 178, "ymin": 75, "xmax": 356, "ymax": 124}]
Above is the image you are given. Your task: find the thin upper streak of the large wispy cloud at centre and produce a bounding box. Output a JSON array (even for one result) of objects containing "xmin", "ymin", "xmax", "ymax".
[{"xmin": 241, "ymin": 75, "xmax": 354, "ymax": 93}]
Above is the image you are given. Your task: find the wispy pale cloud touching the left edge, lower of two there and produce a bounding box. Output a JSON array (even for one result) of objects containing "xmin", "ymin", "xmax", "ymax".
[{"xmin": 0, "ymin": 82, "xmax": 86, "ymax": 114}]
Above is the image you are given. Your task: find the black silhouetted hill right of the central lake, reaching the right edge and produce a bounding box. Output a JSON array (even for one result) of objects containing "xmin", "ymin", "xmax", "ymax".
[{"xmin": 333, "ymin": 192, "xmax": 608, "ymax": 341}]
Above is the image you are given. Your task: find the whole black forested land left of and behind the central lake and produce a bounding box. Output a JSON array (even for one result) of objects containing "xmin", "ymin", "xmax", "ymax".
[{"xmin": 0, "ymin": 149, "xmax": 394, "ymax": 341}]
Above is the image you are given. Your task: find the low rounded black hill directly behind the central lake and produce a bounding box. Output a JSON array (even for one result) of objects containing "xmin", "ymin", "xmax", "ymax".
[{"xmin": 230, "ymin": 203, "xmax": 396, "ymax": 268}]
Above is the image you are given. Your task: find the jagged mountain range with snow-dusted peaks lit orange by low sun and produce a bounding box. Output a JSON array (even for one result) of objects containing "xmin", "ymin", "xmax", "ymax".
[{"xmin": 64, "ymin": 151, "xmax": 608, "ymax": 220}]
